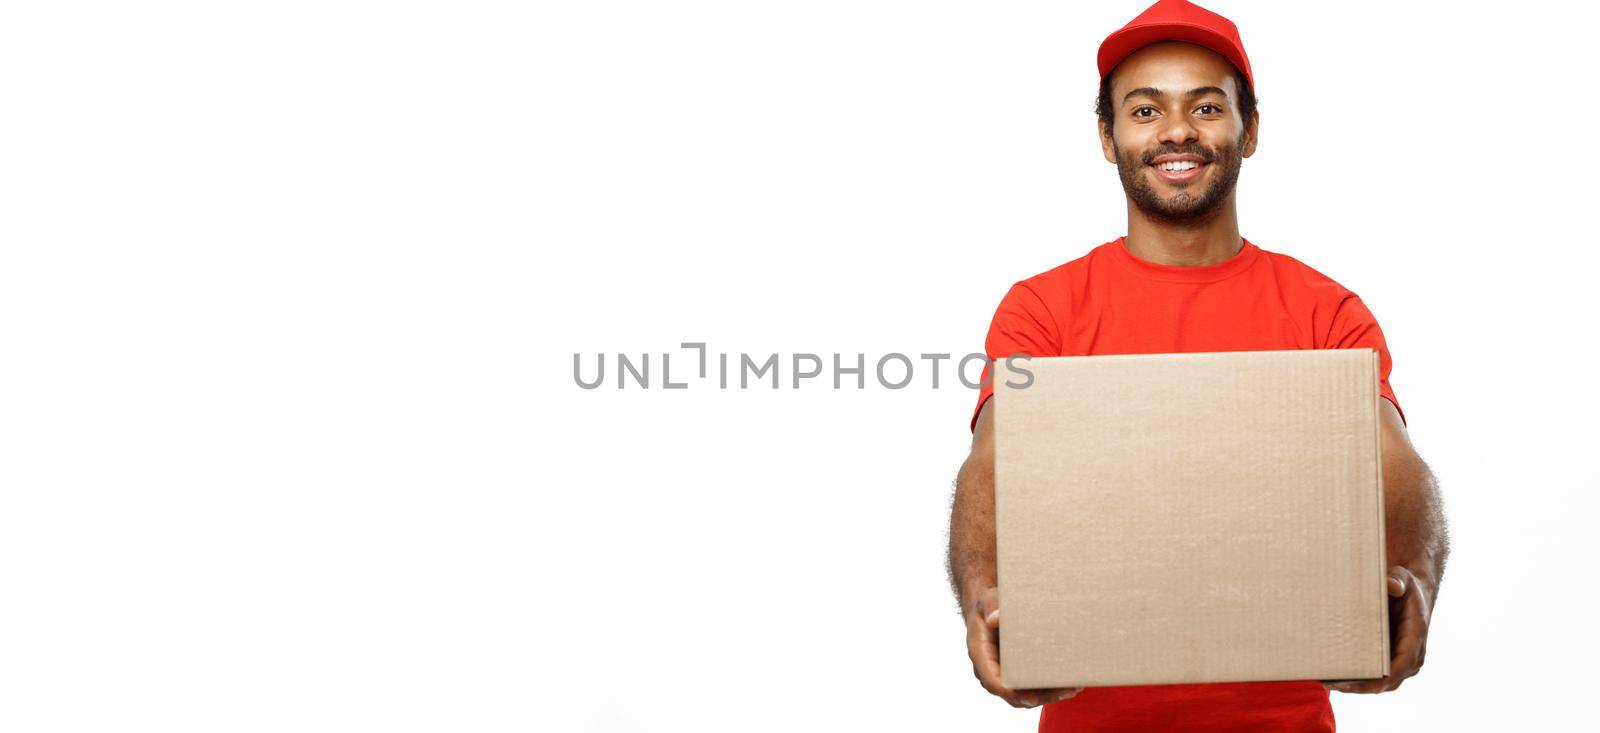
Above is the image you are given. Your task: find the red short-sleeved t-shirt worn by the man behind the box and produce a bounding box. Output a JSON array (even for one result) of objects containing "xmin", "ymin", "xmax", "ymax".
[{"xmin": 973, "ymin": 238, "xmax": 1405, "ymax": 733}]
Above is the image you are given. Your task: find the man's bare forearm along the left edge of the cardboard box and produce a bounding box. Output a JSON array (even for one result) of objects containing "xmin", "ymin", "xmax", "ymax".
[{"xmin": 949, "ymin": 455, "xmax": 997, "ymax": 613}]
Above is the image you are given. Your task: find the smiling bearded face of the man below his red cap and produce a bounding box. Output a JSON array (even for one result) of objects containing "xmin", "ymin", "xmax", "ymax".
[{"xmin": 1101, "ymin": 42, "xmax": 1259, "ymax": 222}]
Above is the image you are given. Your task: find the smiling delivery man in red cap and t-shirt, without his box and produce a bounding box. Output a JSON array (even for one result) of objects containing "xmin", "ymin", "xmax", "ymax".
[{"xmin": 949, "ymin": 0, "xmax": 1446, "ymax": 733}]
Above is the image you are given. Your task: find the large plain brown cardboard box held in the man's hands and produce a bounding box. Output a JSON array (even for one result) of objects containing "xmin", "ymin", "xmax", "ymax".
[{"xmin": 994, "ymin": 349, "xmax": 1389, "ymax": 688}]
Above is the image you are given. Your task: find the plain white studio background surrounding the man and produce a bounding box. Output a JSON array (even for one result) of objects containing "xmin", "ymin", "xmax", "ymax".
[{"xmin": 0, "ymin": 0, "xmax": 1600, "ymax": 731}]
